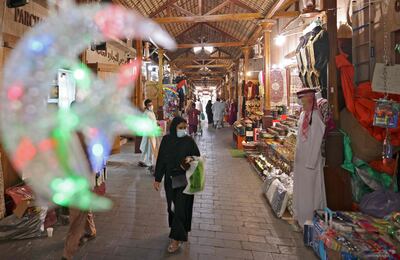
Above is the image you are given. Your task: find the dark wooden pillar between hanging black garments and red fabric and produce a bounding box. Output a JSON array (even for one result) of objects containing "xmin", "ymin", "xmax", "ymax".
[{"xmin": 324, "ymin": 0, "xmax": 340, "ymax": 123}]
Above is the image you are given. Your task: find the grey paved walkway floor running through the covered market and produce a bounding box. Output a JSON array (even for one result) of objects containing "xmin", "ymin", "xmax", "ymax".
[{"xmin": 0, "ymin": 125, "xmax": 315, "ymax": 260}]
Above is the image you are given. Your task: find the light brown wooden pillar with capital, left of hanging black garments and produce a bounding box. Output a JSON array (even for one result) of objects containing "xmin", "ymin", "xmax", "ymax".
[{"xmin": 260, "ymin": 19, "xmax": 275, "ymax": 111}]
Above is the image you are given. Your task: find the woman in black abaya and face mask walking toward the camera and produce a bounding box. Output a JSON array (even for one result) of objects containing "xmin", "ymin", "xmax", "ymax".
[{"xmin": 154, "ymin": 117, "xmax": 200, "ymax": 253}]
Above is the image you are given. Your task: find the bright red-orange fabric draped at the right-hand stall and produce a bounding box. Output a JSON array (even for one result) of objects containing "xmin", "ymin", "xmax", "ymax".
[{"xmin": 336, "ymin": 54, "xmax": 400, "ymax": 146}]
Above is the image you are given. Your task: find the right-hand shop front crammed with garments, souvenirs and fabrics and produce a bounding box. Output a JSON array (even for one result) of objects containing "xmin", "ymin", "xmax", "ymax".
[{"xmin": 233, "ymin": 1, "xmax": 400, "ymax": 259}]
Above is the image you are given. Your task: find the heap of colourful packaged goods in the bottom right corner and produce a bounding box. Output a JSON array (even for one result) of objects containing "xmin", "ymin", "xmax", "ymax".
[{"xmin": 310, "ymin": 211, "xmax": 400, "ymax": 259}]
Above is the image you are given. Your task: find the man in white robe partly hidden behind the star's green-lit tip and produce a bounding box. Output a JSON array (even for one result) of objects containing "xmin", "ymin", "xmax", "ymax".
[{"xmin": 139, "ymin": 99, "xmax": 157, "ymax": 168}]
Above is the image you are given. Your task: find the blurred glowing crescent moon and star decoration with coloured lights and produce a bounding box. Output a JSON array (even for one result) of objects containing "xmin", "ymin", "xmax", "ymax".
[{"xmin": 0, "ymin": 1, "xmax": 176, "ymax": 210}]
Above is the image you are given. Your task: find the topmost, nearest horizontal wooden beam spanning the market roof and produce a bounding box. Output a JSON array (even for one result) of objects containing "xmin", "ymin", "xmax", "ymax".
[{"xmin": 153, "ymin": 13, "xmax": 263, "ymax": 24}]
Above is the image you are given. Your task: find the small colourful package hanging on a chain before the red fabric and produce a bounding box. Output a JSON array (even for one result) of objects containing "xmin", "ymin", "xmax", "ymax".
[{"xmin": 374, "ymin": 99, "xmax": 399, "ymax": 128}]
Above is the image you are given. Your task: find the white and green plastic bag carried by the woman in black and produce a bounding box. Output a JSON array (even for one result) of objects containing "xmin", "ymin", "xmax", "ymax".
[{"xmin": 183, "ymin": 157, "xmax": 205, "ymax": 195}]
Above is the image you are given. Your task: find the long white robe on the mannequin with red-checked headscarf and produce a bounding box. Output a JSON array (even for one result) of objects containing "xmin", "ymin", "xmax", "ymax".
[{"xmin": 293, "ymin": 111, "xmax": 326, "ymax": 226}]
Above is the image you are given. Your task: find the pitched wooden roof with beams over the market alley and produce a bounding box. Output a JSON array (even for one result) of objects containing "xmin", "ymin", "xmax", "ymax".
[{"xmin": 115, "ymin": 0, "xmax": 298, "ymax": 86}]
